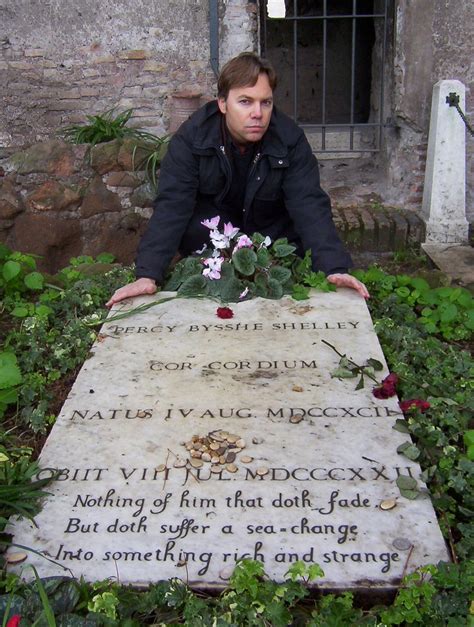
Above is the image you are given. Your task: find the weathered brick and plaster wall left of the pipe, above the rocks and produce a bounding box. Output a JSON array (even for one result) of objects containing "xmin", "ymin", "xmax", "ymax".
[{"xmin": 0, "ymin": 0, "xmax": 214, "ymax": 151}]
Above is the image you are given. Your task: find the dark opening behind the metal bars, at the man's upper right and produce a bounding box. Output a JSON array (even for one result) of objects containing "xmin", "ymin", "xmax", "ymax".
[{"xmin": 262, "ymin": 0, "xmax": 388, "ymax": 151}]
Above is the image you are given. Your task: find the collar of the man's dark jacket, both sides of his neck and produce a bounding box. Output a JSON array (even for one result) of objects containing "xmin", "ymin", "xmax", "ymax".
[{"xmin": 193, "ymin": 100, "xmax": 288, "ymax": 158}]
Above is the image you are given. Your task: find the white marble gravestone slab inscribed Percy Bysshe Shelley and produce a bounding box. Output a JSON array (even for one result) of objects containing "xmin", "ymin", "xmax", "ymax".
[{"xmin": 9, "ymin": 290, "xmax": 449, "ymax": 589}]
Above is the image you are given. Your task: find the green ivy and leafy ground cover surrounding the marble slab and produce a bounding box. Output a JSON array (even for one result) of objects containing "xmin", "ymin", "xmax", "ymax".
[{"xmin": 0, "ymin": 242, "xmax": 474, "ymax": 627}]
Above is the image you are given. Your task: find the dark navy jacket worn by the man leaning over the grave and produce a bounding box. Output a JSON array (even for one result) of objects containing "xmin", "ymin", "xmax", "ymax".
[{"xmin": 136, "ymin": 101, "xmax": 351, "ymax": 282}]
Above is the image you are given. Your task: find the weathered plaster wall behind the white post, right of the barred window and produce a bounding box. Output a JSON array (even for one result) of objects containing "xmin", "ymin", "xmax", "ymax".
[{"xmin": 382, "ymin": 0, "xmax": 474, "ymax": 220}]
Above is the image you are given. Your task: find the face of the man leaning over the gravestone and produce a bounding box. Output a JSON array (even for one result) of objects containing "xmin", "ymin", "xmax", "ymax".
[{"xmin": 217, "ymin": 73, "xmax": 273, "ymax": 146}]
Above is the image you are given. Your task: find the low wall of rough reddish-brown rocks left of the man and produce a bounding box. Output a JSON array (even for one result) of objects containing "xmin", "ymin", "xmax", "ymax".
[{"xmin": 0, "ymin": 140, "xmax": 154, "ymax": 272}]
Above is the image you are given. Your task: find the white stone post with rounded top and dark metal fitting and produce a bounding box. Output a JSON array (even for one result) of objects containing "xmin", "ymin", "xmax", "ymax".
[{"xmin": 422, "ymin": 80, "xmax": 469, "ymax": 244}]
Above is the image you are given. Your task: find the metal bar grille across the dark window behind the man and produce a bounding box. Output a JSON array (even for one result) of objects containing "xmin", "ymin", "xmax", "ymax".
[{"xmin": 260, "ymin": 0, "xmax": 390, "ymax": 153}]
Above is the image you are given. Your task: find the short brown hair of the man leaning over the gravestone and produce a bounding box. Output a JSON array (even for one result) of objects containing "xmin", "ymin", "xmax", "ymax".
[{"xmin": 217, "ymin": 52, "xmax": 277, "ymax": 100}]
